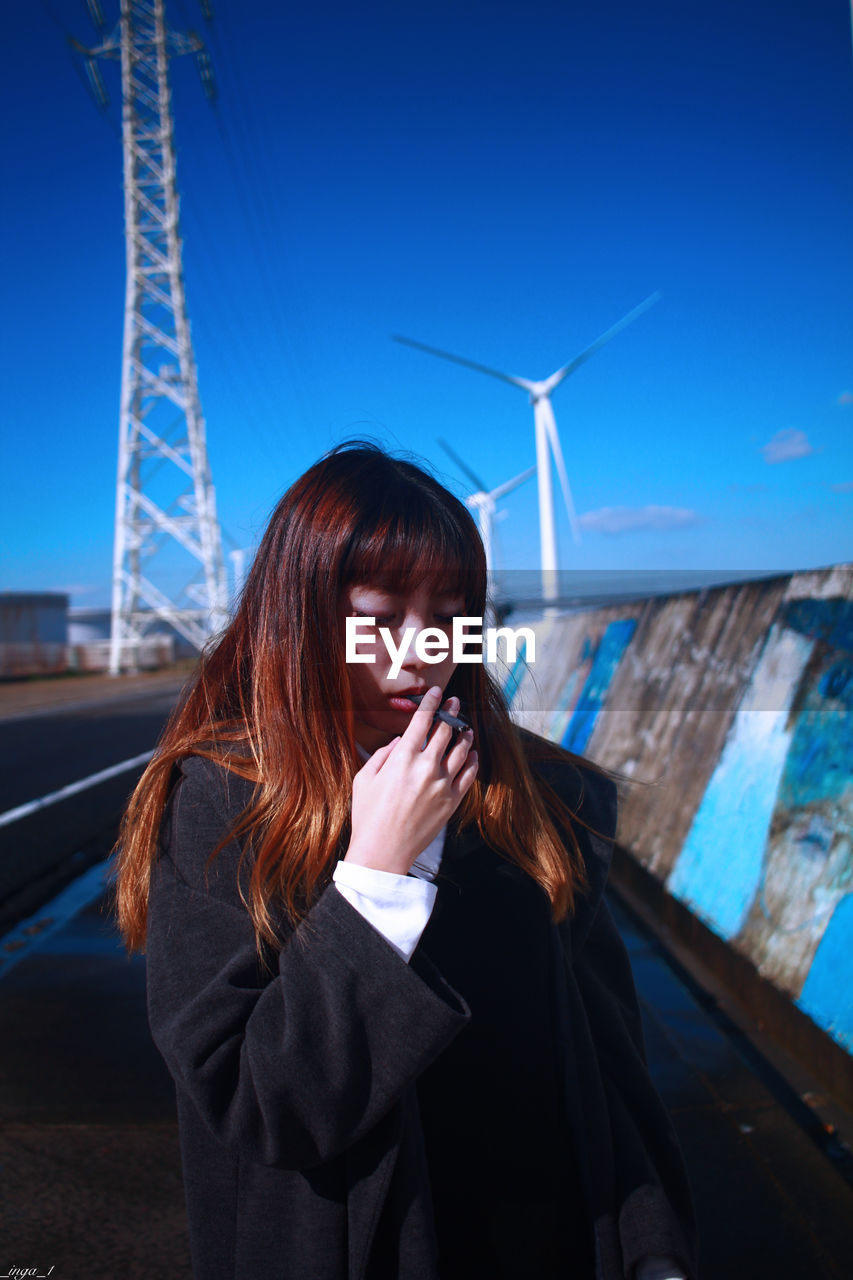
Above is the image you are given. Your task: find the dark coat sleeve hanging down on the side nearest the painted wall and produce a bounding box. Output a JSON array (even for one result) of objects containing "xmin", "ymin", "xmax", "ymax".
[{"xmin": 558, "ymin": 774, "xmax": 695, "ymax": 1277}]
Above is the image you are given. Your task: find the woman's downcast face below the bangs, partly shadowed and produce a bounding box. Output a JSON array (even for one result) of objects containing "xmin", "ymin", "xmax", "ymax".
[{"xmin": 341, "ymin": 584, "xmax": 465, "ymax": 751}]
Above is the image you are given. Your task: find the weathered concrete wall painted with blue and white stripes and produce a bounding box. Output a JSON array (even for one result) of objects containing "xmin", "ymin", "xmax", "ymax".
[{"xmin": 512, "ymin": 564, "xmax": 853, "ymax": 1052}]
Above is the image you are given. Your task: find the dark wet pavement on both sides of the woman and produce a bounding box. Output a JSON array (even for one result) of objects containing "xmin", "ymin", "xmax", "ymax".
[{"xmin": 0, "ymin": 872, "xmax": 853, "ymax": 1280}]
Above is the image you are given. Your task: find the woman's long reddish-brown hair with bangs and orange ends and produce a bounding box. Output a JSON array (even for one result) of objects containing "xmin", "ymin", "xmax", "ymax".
[{"xmin": 117, "ymin": 440, "xmax": 584, "ymax": 948}]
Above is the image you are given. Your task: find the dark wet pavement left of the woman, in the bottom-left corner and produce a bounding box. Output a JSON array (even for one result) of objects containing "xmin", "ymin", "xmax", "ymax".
[{"xmin": 0, "ymin": 875, "xmax": 190, "ymax": 1280}]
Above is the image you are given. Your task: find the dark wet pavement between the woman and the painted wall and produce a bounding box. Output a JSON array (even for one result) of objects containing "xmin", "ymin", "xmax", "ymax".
[{"xmin": 612, "ymin": 902, "xmax": 853, "ymax": 1280}]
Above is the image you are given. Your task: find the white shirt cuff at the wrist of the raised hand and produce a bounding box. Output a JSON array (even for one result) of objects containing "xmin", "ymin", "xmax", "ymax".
[{"xmin": 332, "ymin": 861, "xmax": 438, "ymax": 964}]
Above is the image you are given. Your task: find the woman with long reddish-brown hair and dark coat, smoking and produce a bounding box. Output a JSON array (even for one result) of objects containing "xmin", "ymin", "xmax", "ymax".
[{"xmin": 118, "ymin": 442, "xmax": 695, "ymax": 1280}]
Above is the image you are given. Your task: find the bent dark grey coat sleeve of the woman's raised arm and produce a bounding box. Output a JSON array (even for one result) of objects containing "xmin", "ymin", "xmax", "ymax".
[{"xmin": 147, "ymin": 758, "xmax": 470, "ymax": 1169}]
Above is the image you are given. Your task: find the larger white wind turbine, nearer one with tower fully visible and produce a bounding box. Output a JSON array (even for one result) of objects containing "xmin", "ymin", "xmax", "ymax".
[{"xmin": 392, "ymin": 293, "xmax": 661, "ymax": 600}]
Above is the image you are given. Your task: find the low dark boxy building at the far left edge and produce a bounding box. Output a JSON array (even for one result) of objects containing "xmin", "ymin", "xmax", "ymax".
[{"xmin": 0, "ymin": 591, "xmax": 68, "ymax": 677}]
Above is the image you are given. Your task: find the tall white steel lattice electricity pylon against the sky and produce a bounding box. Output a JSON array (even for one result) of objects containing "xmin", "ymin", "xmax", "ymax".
[{"xmin": 77, "ymin": 0, "xmax": 228, "ymax": 675}]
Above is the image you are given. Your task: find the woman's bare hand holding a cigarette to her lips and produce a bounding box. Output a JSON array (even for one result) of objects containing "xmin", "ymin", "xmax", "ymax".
[{"xmin": 345, "ymin": 687, "xmax": 478, "ymax": 876}]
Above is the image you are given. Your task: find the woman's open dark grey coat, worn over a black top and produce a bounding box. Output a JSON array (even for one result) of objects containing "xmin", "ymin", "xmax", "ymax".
[{"xmin": 147, "ymin": 758, "xmax": 695, "ymax": 1280}]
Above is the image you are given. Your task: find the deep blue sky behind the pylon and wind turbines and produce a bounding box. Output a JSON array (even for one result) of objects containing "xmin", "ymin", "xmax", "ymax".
[{"xmin": 0, "ymin": 0, "xmax": 853, "ymax": 605}]
